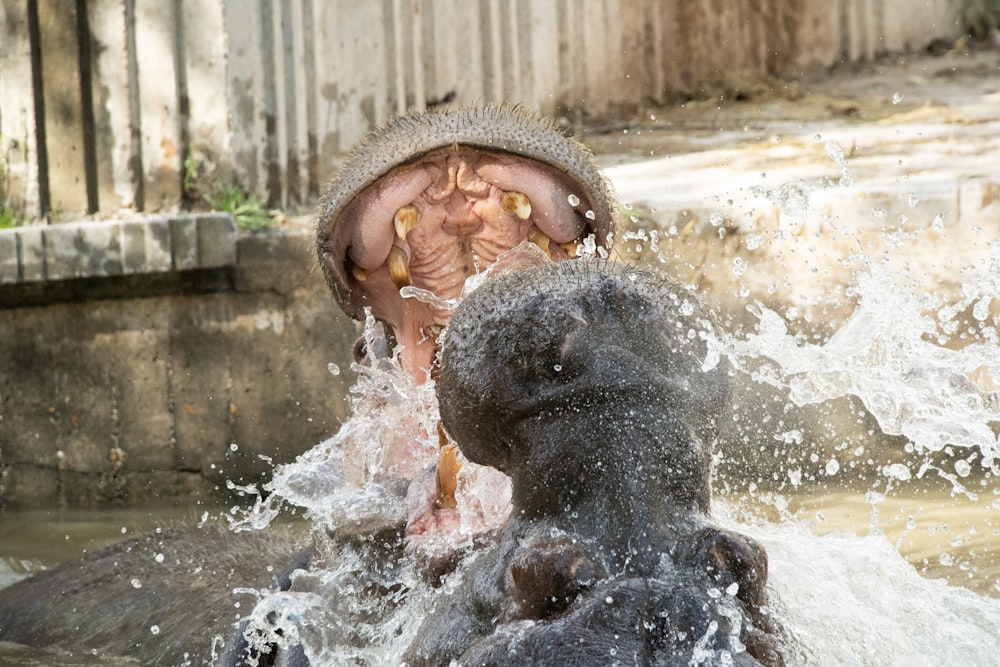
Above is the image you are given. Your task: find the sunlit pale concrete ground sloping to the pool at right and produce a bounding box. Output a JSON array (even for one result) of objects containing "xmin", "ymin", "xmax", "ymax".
[{"xmin": 586, "ymin": 50, "xmax": 1000, "ymax": 328}]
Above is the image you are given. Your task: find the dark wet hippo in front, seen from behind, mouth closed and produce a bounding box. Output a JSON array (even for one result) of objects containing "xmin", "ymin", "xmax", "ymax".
[{"xmin": 406, "ymin": 259, "xmax": 783, "ymax": 667}]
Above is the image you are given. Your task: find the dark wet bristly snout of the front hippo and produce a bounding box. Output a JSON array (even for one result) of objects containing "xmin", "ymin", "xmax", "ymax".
[{"xmin": 438, "ymin": 259, "xmax": 728, "ymax": 519}]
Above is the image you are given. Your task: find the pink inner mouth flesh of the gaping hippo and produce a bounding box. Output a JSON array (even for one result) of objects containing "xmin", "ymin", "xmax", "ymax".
[{"xmin": 325, "ymin": 146, "xmax": 588, "ymax": 542}]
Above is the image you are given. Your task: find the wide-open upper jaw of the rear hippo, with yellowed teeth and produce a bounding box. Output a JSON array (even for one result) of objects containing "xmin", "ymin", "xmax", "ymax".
[{"xmin": 317, "ymin": 105, "xmax": 615, "ymax": 382}]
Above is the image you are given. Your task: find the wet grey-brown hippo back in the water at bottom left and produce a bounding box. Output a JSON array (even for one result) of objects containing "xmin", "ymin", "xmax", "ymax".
[{"xmin": 0, "ymin": 526, "xmax": 308, "ymax": 665}]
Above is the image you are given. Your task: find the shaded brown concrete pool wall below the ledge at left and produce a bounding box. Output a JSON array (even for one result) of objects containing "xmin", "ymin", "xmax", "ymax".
[{"xmin": 0, "ymin": 222, "xmax": 357, "ymax": 506}]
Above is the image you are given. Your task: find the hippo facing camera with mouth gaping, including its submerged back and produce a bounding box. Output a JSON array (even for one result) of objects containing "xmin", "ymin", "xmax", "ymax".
[{"xmin": 0, "ymin": 105, "xmax": 616, "ymax": 664}]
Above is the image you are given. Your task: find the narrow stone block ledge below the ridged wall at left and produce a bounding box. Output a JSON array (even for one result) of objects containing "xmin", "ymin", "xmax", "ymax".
[{"xmin": 0, "ymin": 212, "xmax": 237, "ymax": 285}]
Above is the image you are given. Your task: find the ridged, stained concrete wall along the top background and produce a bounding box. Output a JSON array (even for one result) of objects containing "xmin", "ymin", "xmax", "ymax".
[{"xmin": 0, "ymin": 0, "xmax": 958, "ymax": 219}]
